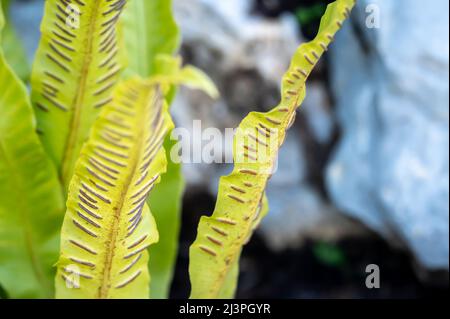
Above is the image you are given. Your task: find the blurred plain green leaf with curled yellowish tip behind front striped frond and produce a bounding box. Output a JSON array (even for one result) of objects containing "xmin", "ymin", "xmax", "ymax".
[{"xmin": 123, "ymin": 0, "xmax": 217, "ymax": 298}]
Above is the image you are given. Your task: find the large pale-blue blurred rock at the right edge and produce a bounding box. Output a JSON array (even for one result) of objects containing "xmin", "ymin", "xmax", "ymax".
[{"xmin": 327, "ymin": 0, "xmax": 449, "ymax": 269}]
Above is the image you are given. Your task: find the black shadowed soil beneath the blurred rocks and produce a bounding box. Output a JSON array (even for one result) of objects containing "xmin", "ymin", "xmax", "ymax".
[{"xmin": 171, "ymin": 192, "xmax": 448, "ymax": 299}]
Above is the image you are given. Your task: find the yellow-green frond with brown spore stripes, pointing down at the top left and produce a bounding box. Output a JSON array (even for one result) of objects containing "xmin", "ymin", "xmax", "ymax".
[{"xmin": 31, "ymin": 0, "xmax": 126, "ymax": 188}]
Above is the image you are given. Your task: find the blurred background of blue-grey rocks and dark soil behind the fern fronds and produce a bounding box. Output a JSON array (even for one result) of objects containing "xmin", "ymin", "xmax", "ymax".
[{"xmin": 7, "ymin": 0, "xmax": 449, "ymax": 298}]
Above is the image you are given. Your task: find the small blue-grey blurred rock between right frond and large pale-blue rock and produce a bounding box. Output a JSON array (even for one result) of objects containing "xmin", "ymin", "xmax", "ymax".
[{"xmin": 260, "ymin": 134, "xmax": 363, "ymax": 250}]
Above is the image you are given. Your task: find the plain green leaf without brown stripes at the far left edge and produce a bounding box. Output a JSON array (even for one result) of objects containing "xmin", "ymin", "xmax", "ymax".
[{"xmin": 0, "ymin": 3, "xmax": 64, "ymax": 298}]
